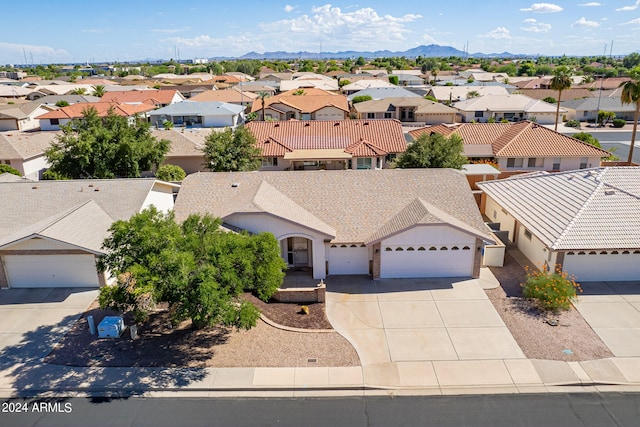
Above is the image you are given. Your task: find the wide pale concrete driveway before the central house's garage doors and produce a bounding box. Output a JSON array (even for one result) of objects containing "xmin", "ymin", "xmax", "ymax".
[{"xmin": 326, "ymin": 270, "xmax": 525, "ymax": 367}]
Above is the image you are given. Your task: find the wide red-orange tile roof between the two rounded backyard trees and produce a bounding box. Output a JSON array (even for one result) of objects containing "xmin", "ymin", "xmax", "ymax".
[{"xmin": 246, "ymin": 120, "xmax": 407, "ymax": 157}]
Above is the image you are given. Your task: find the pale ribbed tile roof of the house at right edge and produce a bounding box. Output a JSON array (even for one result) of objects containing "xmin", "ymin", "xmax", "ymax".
[{"xmin": 478, "ymin": 167, "xmax": 640, "ymax": 250}]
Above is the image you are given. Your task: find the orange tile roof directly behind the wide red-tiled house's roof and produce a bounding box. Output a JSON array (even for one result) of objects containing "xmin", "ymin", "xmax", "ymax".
[{"xmin": 251, "ymin": 88, "xmax": 349, "ymax": 113}]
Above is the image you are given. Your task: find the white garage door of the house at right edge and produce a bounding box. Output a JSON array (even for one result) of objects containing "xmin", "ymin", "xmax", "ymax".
[{"xmin": 563, "ymin": 251, "xmax": 640, "ymax": 282}]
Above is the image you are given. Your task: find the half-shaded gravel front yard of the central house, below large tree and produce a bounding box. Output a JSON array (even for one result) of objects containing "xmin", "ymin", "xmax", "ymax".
[{"xmin": 45, "ymin": 297, "xmax": 360, "ymax": 367}]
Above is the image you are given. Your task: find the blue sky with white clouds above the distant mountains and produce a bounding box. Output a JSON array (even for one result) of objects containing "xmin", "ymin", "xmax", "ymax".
[{"xmin": 0, "ymin": 0, "xmax": 640, "ymax": 64}]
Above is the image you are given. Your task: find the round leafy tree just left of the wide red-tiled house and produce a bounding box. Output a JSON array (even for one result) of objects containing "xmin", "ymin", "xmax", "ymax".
[{"xmin": 203, "ymin": 126, "xmax": 260, "ymax": 172}]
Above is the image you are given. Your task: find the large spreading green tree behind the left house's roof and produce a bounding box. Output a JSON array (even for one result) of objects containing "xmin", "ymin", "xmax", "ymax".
[{"xmin": 45, "ymin": 108, "xmax": 170, "ymax": 179}]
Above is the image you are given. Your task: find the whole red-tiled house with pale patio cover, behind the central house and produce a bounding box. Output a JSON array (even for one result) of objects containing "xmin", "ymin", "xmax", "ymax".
[{"xmin": 247, "ymin": 120, "xmax": 407, "ymax": 170}]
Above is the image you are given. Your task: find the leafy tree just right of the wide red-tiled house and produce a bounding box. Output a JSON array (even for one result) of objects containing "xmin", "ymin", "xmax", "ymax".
[{"xmin": 394, "ymin": 133, "xmax": 467, "ymax": 169}]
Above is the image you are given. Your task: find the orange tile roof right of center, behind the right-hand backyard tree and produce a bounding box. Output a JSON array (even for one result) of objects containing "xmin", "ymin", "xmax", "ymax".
[{"xmin": 409, "ymin": 120, "xmax": 609, "ymax": 157}]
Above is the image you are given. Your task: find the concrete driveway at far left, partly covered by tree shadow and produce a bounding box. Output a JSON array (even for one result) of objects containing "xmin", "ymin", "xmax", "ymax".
[{"xmin": 0, "ymin": 288, "xmax": 98, "ymax": 366}]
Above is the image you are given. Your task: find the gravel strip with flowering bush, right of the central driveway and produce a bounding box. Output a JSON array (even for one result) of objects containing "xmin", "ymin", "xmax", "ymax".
[{"xmin": 486, "ymin": 253, "xmax": 613, "ymax": 361}]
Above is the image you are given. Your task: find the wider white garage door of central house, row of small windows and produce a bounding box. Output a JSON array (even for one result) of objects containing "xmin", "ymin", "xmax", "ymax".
[{"xmin": 380, "ymin": 245, "xmax": 473, "ymax": 279}]
